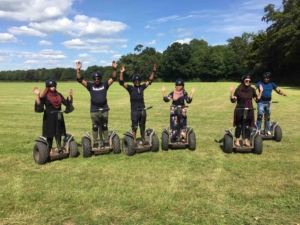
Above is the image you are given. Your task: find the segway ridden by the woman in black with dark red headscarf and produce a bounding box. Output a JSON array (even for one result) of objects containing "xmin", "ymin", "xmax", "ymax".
[{"xmin": 33, "ymin": 110, "xmax": 78, "ymax": 164}]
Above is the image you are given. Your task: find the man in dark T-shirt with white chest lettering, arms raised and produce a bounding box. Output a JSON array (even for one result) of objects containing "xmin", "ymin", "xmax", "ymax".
[{"xmin": 76, "ymin": 61, "xmax": 117, "ymax": 148}]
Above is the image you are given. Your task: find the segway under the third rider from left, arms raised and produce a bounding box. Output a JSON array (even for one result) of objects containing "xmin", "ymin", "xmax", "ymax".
[{"xmin": 122, "ymin": 106, "xmax": 159, "ymax": 156}]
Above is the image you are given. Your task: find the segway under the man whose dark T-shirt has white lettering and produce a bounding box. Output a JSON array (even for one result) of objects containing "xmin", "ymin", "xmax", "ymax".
[{"xmin": 81, "ymin": 108, "xmax": 121, "ymax": 158}]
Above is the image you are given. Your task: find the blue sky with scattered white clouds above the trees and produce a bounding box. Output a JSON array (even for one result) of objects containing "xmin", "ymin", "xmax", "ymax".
[{"xmin": 0, "ymin": 0, "xmax": 282, "ymax": 71}]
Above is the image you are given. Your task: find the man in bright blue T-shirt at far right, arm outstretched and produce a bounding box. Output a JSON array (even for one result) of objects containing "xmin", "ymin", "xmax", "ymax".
[{"xmin": 254, "ymin": 72, "xmax": 287, "ymax": 135}]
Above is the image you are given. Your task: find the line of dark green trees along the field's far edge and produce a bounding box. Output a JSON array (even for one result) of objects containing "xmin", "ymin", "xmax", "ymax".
[{"xmin": 0, "ymin": 0, "xmax": 300, "ymax": 85}]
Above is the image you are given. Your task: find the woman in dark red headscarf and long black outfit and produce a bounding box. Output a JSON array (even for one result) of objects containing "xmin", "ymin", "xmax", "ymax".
[{"xmin": 33, "ymin": 79, "xmax": 74, "ymax": 154}]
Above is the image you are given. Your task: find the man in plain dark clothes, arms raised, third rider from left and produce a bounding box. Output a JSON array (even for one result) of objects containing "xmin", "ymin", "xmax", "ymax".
[{"xmin": 119, "ymin": 64, "xmax": 156, "ymax": 147}]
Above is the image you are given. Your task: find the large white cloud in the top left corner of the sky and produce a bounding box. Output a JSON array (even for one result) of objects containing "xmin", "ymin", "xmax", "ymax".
[{"xmin": 0, "ymin": 0, "xmax": 74, "ymax": 21}]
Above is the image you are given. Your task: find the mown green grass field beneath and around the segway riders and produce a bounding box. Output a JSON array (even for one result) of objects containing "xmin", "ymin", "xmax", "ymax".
[{"xmin": 0, "ymin": 82, "xmax": 300, "ymax": 225}]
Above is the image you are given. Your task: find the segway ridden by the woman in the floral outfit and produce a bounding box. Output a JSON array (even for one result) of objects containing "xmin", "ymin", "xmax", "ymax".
[{"xmin": 161, "ymin": 105, "xmax": 196, "ymax": 151}]
